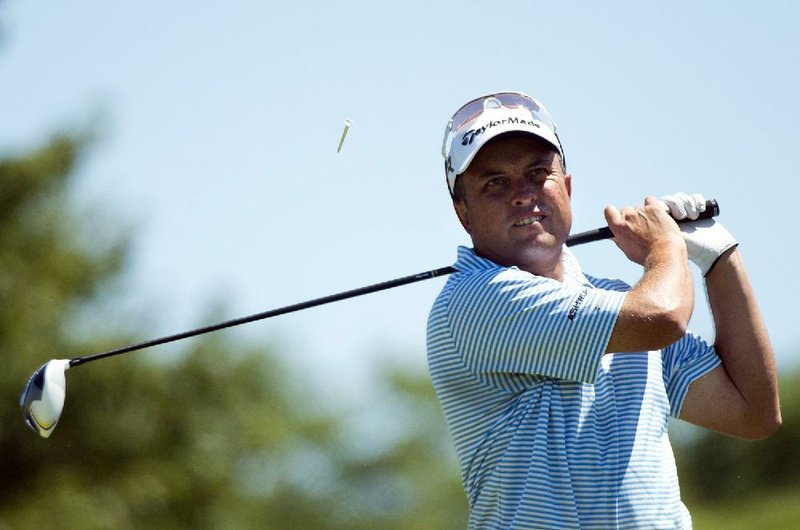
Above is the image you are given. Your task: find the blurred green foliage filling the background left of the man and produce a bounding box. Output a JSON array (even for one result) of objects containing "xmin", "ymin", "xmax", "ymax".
[{"xmin": 0, "ymin": 135, "xmax": 466, "ymax": 530}]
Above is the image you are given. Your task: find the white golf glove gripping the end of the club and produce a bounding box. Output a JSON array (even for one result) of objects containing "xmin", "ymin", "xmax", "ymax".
[{"xmin": 661, "ymin": 193, "xmax": 738, "ymax": 276}]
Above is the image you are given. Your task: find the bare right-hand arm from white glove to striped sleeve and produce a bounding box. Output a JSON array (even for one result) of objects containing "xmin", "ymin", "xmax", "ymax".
[{"xmin": 680, "ymin": 247, "xmax": 781, "ymax": 439}]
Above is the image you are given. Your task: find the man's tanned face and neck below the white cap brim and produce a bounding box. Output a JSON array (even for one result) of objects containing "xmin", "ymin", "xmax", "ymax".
[{"xmin": 454, "ymin": 136, "xmax": 572, "ymax": 279}]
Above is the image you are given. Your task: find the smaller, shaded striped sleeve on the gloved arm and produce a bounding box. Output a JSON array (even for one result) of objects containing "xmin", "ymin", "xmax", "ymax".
[{"xmin": 662, "ymin": 332, "xmax": 722, "ymax": 418}]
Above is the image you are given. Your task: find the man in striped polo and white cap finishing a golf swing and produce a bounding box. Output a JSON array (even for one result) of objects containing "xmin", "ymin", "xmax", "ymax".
[{"xmin": 428, "ymin": 92, "xmax": 781, "ymax": 529}]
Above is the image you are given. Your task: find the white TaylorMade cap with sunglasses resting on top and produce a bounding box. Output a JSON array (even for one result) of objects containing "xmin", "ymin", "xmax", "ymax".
[{"xmin": 442, "ymin": 92, "xmax": 564, "ymax": 194}]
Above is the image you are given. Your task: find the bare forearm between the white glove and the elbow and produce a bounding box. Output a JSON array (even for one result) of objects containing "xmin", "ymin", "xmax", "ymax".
[{"xmin": 706, "ymin": 248, "xmax": 781, "ymax": 438}]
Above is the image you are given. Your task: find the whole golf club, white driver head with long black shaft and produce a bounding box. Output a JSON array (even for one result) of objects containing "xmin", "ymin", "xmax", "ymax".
[{"xmin": 20, "ymin": 199, "xmax": 719, "ymax": 438}]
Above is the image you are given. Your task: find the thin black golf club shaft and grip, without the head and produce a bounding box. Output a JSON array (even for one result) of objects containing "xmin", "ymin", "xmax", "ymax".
[{"xmin": 69, "ymin": 199, "xmax": 719, "ymax": 367}]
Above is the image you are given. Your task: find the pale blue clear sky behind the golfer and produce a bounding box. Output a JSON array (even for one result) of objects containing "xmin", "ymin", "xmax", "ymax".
[{"xmin": 0, "ymin": 0, "xmax": 800, "ymax": 396}]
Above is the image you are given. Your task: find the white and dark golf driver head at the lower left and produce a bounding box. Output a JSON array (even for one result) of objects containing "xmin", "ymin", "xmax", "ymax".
[{"xmin": 19, "ymin": 359, "xmax": 69, "ymax": 438}]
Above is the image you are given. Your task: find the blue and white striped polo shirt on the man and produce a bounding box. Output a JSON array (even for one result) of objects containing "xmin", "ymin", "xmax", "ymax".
[{"xmin": 428, "ymin": 247, "xmax": 720, "ymax": 529}]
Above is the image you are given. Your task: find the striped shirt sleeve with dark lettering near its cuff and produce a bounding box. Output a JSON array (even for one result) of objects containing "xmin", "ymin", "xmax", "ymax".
[{"xmin": 448, "ymin": 268, "xmax": 625, "ymax": 383}]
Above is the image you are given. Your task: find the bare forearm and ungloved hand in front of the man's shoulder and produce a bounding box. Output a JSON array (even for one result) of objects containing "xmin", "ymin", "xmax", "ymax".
[{"xmin": 605, "ymin": 197, "xmax": 694, "ymax": 353}]
